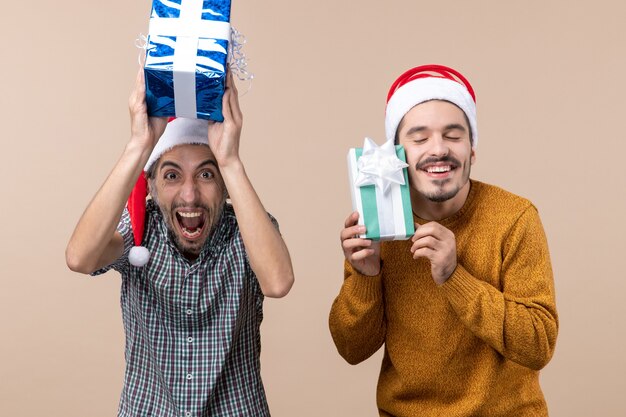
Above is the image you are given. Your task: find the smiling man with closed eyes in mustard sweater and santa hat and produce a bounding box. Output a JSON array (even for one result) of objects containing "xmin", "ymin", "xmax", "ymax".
[{"xmin": 330, "ymin": 65, "xmax": 558, "ymax": 417}]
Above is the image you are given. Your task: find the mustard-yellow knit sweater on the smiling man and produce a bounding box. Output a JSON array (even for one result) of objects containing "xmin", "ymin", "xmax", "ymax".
[{"xmin": 330, "ymin": 181, "xmax": 558, "ymax": 417}]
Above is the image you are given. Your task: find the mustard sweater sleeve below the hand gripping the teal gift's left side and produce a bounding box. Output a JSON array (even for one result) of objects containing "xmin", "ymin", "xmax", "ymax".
[{"xmin": 329, "ymin": 261, "xmax": 386, "ymax": 365}]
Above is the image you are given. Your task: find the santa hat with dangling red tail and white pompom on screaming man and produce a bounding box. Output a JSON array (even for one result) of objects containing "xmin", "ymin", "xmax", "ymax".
[{"xmin": 127, "ymin": 117, "xmax": 209, "ymax": 267}]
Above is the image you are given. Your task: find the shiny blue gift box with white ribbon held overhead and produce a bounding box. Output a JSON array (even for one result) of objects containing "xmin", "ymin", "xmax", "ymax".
[{"xmin": 144, "ymin": 0, "xmax": 231, "ymax": 122}]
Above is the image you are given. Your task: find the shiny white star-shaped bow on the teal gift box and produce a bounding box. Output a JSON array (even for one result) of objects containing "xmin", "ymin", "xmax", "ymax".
[{"xmin": 354, "ymin": 138, "xmax": 409, "ymax": 193}]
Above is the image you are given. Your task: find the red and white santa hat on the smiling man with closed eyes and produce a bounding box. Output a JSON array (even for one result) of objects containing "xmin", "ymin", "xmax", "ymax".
[{"xmin": 385, "ymin": 65, "xmax": 478, "ymax": 148}]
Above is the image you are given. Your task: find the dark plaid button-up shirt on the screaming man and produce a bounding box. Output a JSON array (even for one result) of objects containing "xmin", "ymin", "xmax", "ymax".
[{"xmin": 94, "ymin": 201, "xmax": 275, "ymax": 417}]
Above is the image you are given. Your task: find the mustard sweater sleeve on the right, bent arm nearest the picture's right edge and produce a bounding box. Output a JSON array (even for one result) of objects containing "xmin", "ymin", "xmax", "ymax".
[{"xmin": 440, "ymin": 206, "xmax": 558, "ymax": 370}]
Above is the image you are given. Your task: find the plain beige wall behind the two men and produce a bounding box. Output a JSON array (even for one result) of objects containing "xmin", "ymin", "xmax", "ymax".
[{"xmin": 0, "ymin": 0, "xmax": 626, "ymax": 417}]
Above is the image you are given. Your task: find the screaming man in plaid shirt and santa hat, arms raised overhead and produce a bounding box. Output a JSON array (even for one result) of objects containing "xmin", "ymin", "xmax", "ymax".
[{"xmin": 66, "ymin": 71, "xmax": 294, "ymax": 417}]
